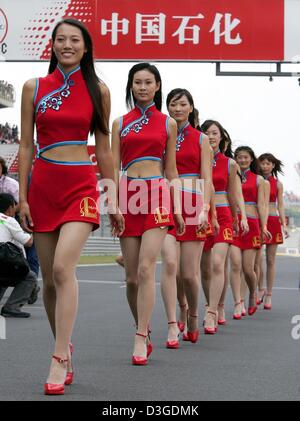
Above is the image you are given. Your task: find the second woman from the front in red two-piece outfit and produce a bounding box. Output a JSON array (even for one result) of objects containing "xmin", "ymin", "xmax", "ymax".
[{"xmin": 112, "ymin": 63, "xmax": 184, "ymax": 365}]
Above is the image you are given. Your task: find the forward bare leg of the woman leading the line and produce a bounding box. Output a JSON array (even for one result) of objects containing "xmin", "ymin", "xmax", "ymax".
[{"xmin": 47, "ymin": 222, "xmax": 92, "ymax": 384}]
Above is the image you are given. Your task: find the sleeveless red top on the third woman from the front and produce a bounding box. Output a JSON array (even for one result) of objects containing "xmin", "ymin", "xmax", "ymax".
[{"xmin": 176, "ymin": 123, "xmax": 203, "ymax": 177}]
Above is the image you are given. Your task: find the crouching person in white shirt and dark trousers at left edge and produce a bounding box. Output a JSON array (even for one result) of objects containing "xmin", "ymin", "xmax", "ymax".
[{"xmin": 0, "ymin": 193, "xmax": 37, "ymax": 318}]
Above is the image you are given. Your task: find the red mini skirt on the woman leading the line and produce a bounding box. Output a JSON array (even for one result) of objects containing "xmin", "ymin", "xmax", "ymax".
[{"xmin": 28, "ymin": 159, "xmax": 100, "ymax": 232}]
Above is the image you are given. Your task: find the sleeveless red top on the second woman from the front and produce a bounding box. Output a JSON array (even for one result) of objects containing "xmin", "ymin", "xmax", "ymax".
[{"xmin": 120, "ymin": 103, "xmax": 169, "ymax": 170}]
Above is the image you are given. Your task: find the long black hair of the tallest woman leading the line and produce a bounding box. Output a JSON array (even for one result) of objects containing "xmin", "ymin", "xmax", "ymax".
[{"xmin": 48, "ymin": 18, "xmax": 109, "ymax": 134}]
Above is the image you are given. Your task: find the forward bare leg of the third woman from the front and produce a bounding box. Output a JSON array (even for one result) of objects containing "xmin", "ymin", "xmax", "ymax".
[{"xmin": 179, "ymin": 241, "xmax": 204, "ymax": 332}]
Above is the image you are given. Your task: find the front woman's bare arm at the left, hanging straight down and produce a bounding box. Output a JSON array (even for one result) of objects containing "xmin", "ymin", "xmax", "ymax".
[{"xmin": 19, "ymin": 79, "xmax": 36, "ymax": 232}]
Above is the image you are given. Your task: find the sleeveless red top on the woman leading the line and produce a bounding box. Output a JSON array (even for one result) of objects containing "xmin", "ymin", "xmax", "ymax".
[{"xmin": 34, "ymin": 65, "xmax": 93, "ymax": 163}]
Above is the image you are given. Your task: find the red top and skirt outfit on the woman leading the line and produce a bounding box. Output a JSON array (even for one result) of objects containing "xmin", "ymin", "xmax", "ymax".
[{"xmin": 28, "ymin": 65, "xmax": 100, "ymax": 232}]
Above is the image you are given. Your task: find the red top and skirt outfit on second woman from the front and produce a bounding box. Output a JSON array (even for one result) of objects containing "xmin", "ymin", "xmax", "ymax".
[{"xmin": 119, "ymin": 103, "xmax": 174, "ymax": 237}]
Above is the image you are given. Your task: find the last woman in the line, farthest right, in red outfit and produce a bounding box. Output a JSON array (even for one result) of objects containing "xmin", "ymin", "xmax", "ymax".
[{"xmin": 258, "ymin": 153, "xmax": 288, "ymax": 310}]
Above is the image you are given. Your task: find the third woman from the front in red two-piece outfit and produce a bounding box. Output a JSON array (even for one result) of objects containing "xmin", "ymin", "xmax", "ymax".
[{"xmin": 162, "ymin": 89, "xmax": 212, "ymax": 347}]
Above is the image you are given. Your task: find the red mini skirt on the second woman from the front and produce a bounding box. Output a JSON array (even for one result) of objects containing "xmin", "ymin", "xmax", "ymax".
[{"xmin": 119, "ymin": 176, "xmax": 174, "ymax": 238}]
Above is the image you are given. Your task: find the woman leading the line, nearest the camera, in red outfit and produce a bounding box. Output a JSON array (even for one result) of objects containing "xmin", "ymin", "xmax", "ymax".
[{"xmin": 19, "ymin": 19, "xmax": 123, "ymax": 395}]
